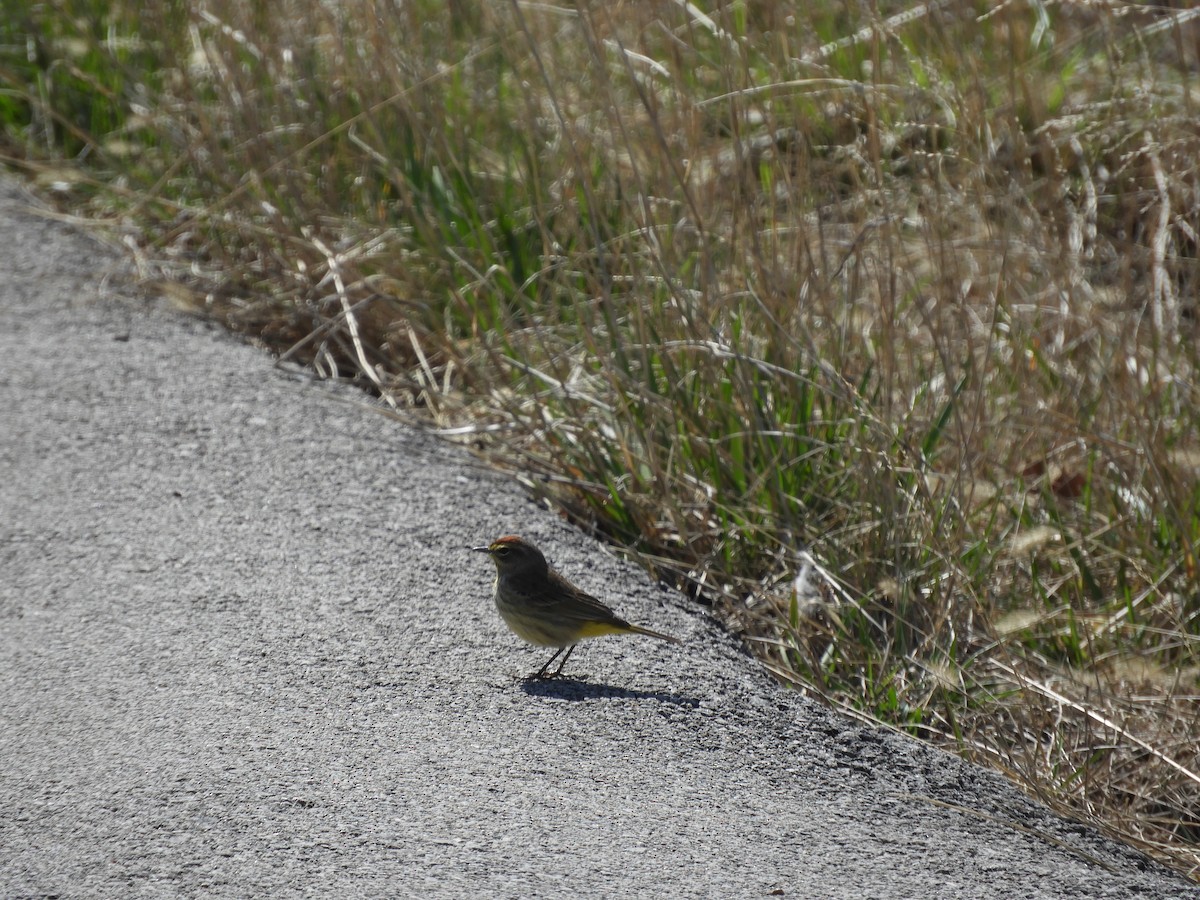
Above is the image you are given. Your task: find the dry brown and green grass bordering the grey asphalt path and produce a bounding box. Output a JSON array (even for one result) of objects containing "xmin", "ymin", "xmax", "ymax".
[{"xmin": 7, "ymin": 0, "xmax": 1200, "ymax": 877}]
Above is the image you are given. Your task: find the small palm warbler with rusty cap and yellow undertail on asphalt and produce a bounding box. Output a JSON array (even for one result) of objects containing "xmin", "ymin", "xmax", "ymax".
[{"xmin": 472, "ymin": 535, "xmax": 679, "ymax": 678}]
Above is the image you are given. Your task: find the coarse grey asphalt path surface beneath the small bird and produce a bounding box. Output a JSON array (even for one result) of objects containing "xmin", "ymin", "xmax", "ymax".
[{"xmin": 0, "ymin": 181, "xmax": 1200, "ymax": 900}]
